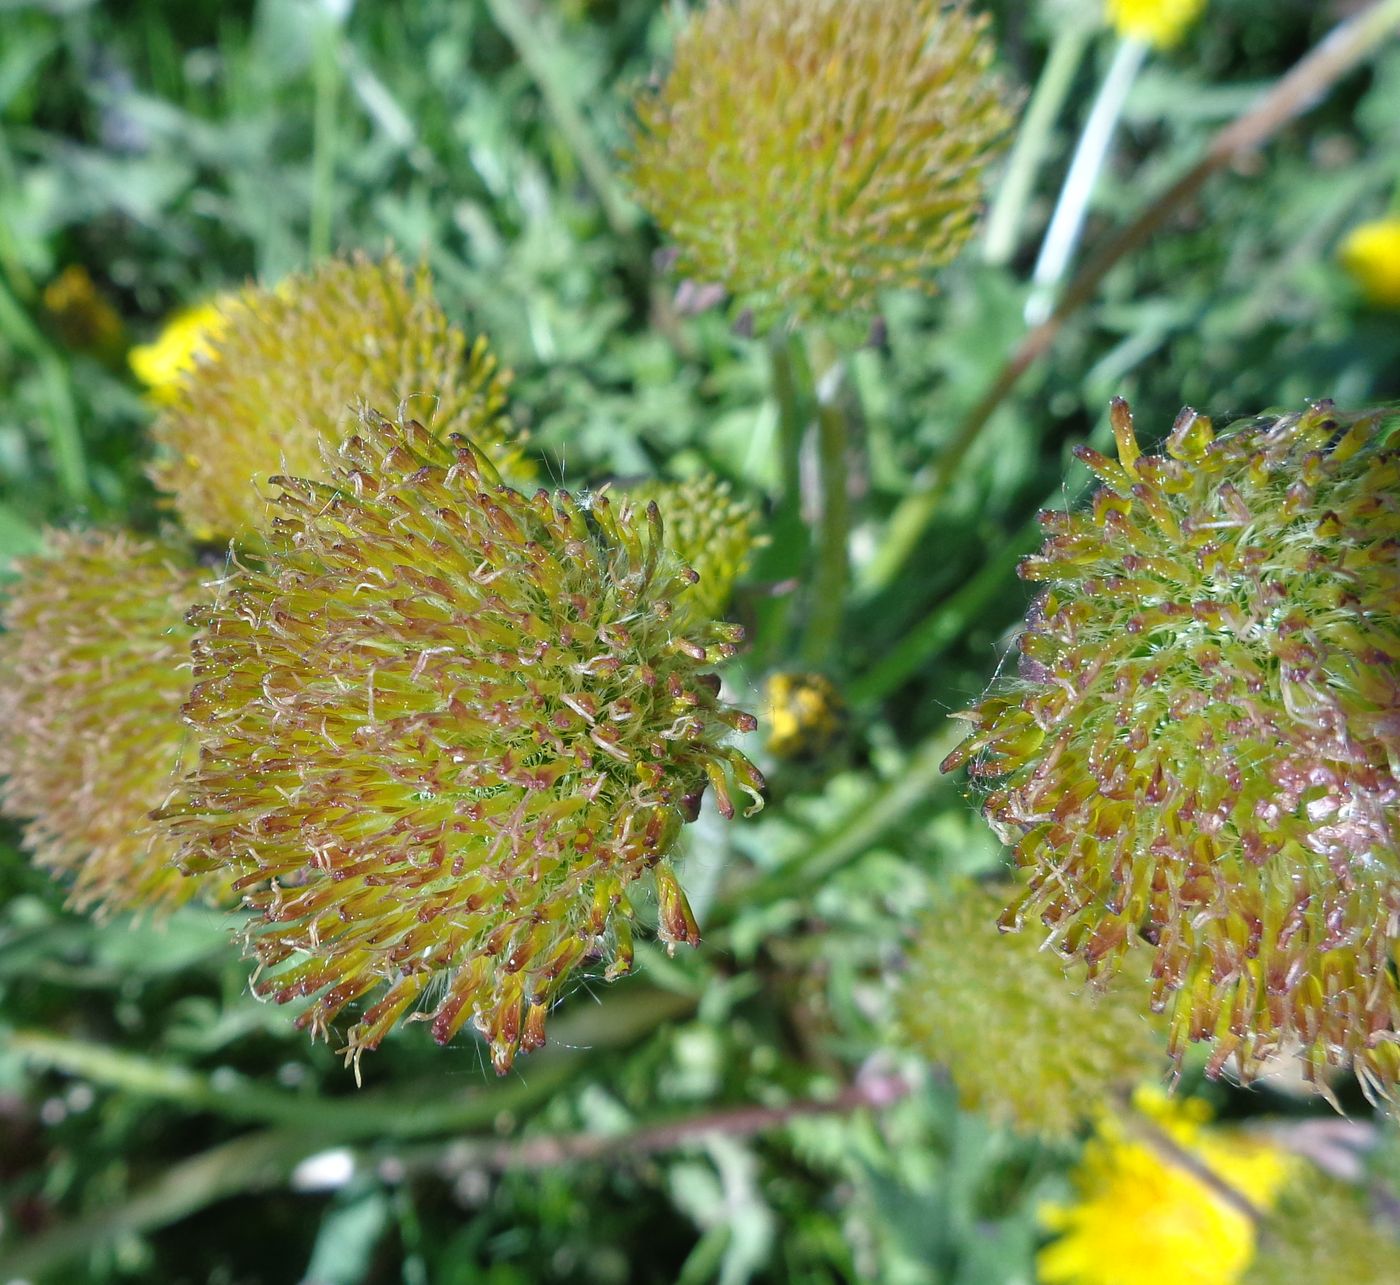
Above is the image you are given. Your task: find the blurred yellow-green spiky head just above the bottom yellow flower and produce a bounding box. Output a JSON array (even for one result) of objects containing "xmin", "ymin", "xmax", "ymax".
[{"xmin": 899, "ymin": 883, "xmax": 1166, "ymax": 1137}]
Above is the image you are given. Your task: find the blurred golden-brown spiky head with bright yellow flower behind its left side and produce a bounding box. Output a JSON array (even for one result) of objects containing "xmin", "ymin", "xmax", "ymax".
[{"xmin": 147, "ymin": 255, "xmax": 519, "ymax": 540}]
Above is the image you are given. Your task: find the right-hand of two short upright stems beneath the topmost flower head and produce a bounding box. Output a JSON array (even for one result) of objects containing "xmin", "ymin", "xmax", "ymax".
[{"xmin": 802, "ymin": 336, "xmax": 851, "ymax": 669}]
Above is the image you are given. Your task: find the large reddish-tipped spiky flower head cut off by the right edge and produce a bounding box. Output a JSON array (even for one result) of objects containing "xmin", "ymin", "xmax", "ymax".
[{"xmin": 945, "ymin": 402, "xmax": 1400, "ymax": 1092}]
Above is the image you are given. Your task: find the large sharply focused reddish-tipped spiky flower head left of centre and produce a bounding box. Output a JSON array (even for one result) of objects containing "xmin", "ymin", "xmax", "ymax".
[{"xmin": 168, "ymin": 414, "xmax": 762, "ymax": 1071}]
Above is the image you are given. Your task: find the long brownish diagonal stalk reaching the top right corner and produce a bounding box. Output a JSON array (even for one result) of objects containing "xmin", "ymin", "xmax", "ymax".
[{"xmin": 860, "ymin": 0, "xmax": 1400, "ymax": 598}]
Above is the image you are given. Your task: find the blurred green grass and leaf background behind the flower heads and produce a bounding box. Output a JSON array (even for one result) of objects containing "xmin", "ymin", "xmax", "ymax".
[{"xmin": 0, "ymin": 0, "xmax": 1400, "ymax": 1285}]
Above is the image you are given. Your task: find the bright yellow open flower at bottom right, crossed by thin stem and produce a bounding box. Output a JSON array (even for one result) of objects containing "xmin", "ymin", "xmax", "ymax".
[{"xmin": 1036, "ymin": 1089, "xmax": 1295, "ymax": 1285}]
